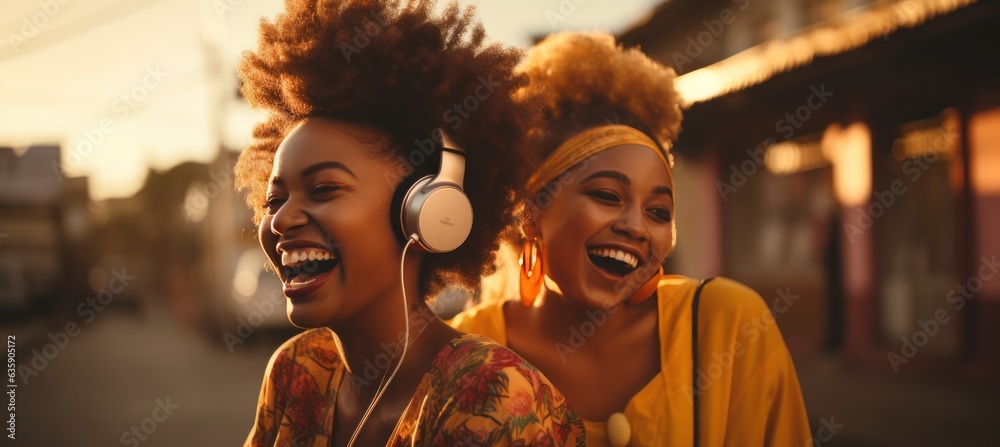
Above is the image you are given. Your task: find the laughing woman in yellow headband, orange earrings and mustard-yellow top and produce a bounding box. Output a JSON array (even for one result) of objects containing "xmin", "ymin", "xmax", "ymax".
[{"xmin": 452, "ymin": 33, "xmax": 811, "ymax": 446}]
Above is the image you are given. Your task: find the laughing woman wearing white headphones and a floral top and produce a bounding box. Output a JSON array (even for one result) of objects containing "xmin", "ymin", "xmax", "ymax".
[{"xmin": 236, "ymin": 0, "xmax": 583, "ymax": 447}]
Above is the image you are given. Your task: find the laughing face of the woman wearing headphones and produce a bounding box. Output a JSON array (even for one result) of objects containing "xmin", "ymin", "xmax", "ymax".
[{"xmin": 258, "ymin": 118, "xmax": 412, "ymax": 328}]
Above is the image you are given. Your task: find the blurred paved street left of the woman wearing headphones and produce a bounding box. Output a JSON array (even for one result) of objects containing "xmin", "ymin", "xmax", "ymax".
[{"xmin": 4, "ymin": 309, "xmax": 280, "ymax": 447}]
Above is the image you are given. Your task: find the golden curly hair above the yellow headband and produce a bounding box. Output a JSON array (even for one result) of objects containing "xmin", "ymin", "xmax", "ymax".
[{"xmin": 520, "ymin": 32, "xmax": 681, "ymax": 157}]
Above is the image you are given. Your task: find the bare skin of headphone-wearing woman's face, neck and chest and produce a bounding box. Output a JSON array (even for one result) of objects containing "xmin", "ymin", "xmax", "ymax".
[{"xmin": 258, "ymin": 118, "xmax": 460, "ymax": 446}]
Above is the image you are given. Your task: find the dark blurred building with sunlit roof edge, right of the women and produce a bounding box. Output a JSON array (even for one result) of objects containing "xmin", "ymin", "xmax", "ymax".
[{"xmin": 620, "ymin": 0, "xmax": 1000, "ymax": 374}]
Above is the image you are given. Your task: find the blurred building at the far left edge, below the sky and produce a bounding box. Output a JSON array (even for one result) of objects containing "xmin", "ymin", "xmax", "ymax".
[{"xmin": 0, "ymin": 146, "xmax": 90, "ymax": 315}]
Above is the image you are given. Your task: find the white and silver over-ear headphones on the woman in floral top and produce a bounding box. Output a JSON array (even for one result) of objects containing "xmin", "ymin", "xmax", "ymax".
[{"xmin": 399, "ymin": 131, "xmax": 472, "ymax": 253}]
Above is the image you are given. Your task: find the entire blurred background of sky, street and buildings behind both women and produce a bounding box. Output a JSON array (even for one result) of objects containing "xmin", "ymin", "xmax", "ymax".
[{"xmin": 0, "ymin": 0, "xmax": 1000, "ymax": 446}]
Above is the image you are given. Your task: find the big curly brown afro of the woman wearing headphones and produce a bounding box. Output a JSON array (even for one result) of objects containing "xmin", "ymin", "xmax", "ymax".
[{"xmin": 236, "ymin": 0, "xmax": 540, "ymax": 295}]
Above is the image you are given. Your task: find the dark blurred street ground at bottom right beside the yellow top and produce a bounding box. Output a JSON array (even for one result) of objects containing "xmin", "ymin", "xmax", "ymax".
[{"xmin": 796, "ymin": 357, "xmax": 1000, "ymax": 447}]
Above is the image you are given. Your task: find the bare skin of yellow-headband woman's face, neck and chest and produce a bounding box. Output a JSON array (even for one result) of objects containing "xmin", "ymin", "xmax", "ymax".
[{"xmin": 504, "ymin": 145, "xmax": 674, "ymax": 421}]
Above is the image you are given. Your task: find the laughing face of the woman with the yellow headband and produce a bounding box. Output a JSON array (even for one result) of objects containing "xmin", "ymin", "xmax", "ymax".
[{"xmin": 526, "ymin": 145, "xmax": 674, "ymax": 308}]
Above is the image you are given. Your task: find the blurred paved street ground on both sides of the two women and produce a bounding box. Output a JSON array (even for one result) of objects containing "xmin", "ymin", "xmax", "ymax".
[{"xmin": 4, "ymin": 302, "xmax": 1000, "ymax": 447}]
